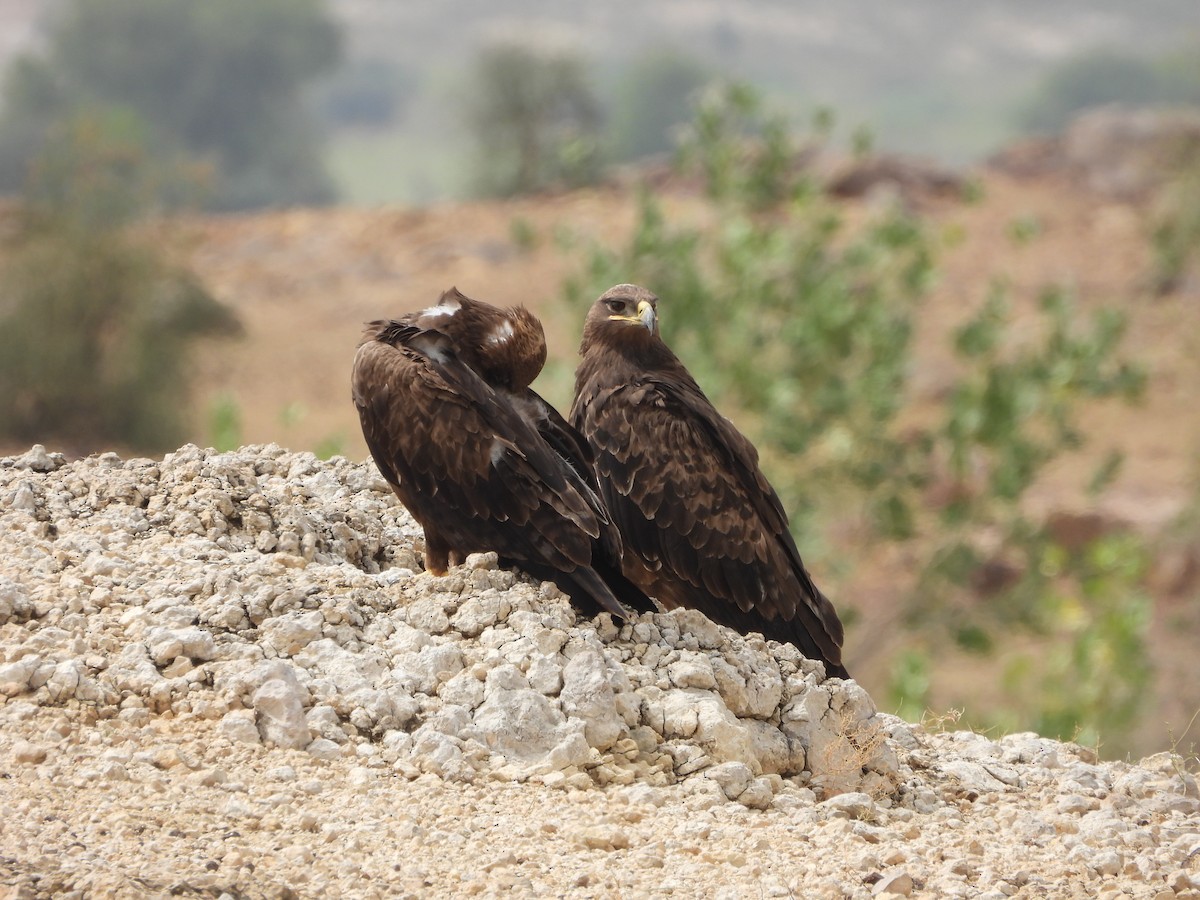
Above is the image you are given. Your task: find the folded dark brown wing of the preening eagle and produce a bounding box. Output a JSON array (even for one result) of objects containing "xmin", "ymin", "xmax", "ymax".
[{"xmin": 352, "ymin": 323, "xmax": 601, "ymax": 571}]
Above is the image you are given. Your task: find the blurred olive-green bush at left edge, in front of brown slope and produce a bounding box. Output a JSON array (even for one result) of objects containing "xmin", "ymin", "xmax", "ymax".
[{"xmin": 0, "ymin": 113, "xmax": 236, "ymax": 452}]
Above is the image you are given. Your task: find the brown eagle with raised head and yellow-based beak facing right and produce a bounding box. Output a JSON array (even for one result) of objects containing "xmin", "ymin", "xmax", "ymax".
[{"xmin": 570, "ymin": 284, "xmax": 850, "ymax": 678}]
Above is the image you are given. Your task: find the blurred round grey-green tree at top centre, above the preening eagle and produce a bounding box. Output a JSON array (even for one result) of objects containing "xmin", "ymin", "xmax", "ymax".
[{"xmin": 466, "ymin": 43, "xmax": 602, "ymax": 196}]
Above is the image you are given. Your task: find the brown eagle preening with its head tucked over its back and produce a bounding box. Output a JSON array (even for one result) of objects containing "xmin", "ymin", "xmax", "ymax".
[{"xmin": 352, "ymin": 288, "xmax": 653, "ymax": 616}]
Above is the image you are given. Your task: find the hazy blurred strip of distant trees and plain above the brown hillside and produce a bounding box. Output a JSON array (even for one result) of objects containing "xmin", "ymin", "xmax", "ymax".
[{"xmin": 0, "ymin": 0, "xmax": 1200, "ymax": 209}]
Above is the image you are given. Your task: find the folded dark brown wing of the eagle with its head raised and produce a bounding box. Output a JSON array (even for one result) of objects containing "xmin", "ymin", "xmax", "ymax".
[{"xmin": 574, "ymin": 377, "xmax": 842, "ymax": 670}]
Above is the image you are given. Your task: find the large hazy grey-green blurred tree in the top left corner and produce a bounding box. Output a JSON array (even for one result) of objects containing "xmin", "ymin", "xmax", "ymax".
[{"xmin": 0, "ymin": 0, "xmax": 341, "ymax": 209}]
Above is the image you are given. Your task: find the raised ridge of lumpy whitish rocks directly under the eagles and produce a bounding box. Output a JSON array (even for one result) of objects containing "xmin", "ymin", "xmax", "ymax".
[{"xmin": 0, "ymin": 446, "xmax": 901, "ymax": 804}]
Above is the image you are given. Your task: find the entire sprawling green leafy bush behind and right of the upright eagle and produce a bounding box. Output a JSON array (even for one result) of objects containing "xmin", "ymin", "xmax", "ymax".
[{"xmin": 556, "ymin": 85, "xmax": 1148, "ymax": 753}]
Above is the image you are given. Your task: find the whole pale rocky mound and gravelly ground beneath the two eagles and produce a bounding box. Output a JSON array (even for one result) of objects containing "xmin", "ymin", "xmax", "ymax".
[{"xmin": 0, "ymin": 445, "xmax": 1200, "ymax": 896}]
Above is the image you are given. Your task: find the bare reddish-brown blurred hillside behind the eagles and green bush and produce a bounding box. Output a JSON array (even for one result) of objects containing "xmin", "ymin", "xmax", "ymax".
[{"xmin": 180, "ymin": 153, "xmax": 1200, "ymax": 524}]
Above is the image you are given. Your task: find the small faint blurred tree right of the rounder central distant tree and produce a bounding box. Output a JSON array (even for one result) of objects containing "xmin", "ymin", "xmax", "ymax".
[{"xmin": 611, "ymin": 50, "xmax": 712, "ymax": 160}]
